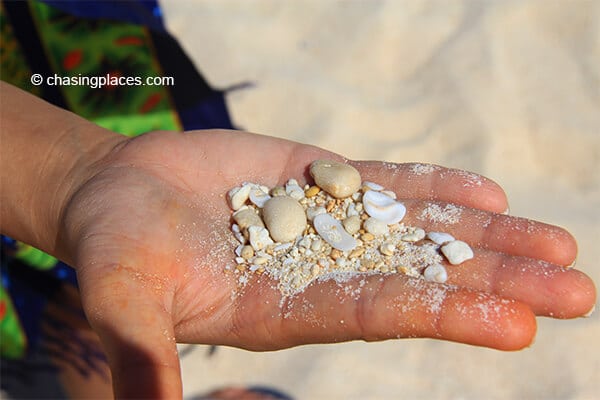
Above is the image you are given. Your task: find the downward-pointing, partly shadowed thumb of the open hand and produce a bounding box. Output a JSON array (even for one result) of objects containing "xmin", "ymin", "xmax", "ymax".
[{"xmin": 80, "ymin": 266, "xmax": 182, "ymax": 398}]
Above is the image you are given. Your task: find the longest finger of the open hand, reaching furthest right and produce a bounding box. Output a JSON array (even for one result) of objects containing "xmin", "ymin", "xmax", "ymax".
[{"xmin": 447, "ymin": 249, "xmax": 596, "ymax": 318}]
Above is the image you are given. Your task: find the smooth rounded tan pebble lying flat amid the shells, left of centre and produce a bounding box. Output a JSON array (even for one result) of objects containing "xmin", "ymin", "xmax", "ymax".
[{"xmin": 263, "ymin": 196, "xmax": 306, "ymax": 242}]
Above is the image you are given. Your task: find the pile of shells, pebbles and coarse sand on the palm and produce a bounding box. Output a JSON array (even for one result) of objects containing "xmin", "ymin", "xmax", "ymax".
[{"xmin": 227, "ymin": 160, "xmax": 473, "ymax": 295}]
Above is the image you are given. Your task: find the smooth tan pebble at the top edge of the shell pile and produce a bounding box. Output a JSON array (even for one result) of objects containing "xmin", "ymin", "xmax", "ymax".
[{"xmin": 310, "ymin": 160, "xmax": 361, "ymax": 199}]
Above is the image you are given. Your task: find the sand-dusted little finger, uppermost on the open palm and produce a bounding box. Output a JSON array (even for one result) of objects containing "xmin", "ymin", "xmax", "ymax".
[{"xmin": 356, "ymin": 162, "xmax": 508, "ymax": 213}]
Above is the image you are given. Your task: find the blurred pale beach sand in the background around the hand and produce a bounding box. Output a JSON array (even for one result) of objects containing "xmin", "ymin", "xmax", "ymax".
[{"xmin": 164, "ymin": 0, "xmax": 600, "ymax": 399}]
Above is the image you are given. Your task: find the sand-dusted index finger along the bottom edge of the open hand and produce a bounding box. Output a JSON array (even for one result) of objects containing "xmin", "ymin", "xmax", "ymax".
[{"xmin": 230, "ymin": 275, "xmax": 536, "ymax": 350}]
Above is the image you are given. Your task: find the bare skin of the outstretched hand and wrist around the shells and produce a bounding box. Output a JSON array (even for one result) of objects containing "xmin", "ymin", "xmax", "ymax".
[{"xmin": 0, "ymin": 83, "xmax": 596, "ymax": 398}]
